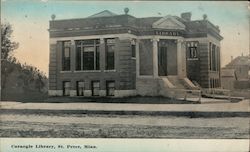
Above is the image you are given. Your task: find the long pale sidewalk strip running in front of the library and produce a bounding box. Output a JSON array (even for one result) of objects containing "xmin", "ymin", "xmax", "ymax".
[{"xmin": 0, "ymin": 100, "xmax": 250, "ymax": 112}]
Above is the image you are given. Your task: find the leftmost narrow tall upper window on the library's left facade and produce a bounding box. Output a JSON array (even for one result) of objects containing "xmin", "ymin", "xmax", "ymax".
[{"xmin": 62, "ymin": 41, "xmax": 71, "ymax": 71}]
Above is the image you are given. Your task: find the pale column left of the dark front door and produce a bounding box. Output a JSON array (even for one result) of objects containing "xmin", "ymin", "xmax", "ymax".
[{"xmin": 153, "ymin": 38, "xmax": 159, "ymax": 78}]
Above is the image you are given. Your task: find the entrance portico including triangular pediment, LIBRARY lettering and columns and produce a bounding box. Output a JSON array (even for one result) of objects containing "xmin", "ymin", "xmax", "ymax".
[{"xmin": 137, "ymin": 15, "xmax": 186, "ymax": 78}]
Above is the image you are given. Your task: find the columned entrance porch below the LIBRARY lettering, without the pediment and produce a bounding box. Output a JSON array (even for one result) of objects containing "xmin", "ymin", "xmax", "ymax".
[{"xmin": 136, "ymin": 36, "xmax": 186, "ymax": 78}]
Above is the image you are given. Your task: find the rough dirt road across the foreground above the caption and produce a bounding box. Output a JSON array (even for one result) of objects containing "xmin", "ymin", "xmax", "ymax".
[{"xmin": 0, "ymin": 113, "xmax": 249, "ymax": 139}]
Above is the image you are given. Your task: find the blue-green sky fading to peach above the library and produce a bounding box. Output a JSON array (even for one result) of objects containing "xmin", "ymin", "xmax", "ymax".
[{"xmin": 1, "ymin": 0, "xmax": 250, "ymax": 75}]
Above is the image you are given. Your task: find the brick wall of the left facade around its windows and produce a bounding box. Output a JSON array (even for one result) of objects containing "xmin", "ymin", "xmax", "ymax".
[{"xmin": 49, "ymin": 38, "xmax": 136, "ymax": 94}]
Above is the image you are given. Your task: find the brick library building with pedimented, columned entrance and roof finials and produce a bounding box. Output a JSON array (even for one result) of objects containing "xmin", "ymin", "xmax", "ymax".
[{"xmin": 49, "ymin": 9, "xmax": 223, "ymax": 97}]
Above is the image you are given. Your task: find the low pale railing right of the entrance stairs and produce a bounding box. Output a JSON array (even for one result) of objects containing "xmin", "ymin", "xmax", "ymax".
[{"xmin": 202, "ymin": 88, "xmax": 232, "ymax": 101}]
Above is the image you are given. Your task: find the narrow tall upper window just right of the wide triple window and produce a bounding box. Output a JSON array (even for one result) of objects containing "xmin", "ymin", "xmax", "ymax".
[{"xmin": 105, "ymin": 39, "xmax": 115, "ymax": 70}]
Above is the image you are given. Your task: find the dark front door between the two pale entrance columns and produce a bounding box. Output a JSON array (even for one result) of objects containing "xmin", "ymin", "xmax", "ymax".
[{"xmin": 158, "ymin": 46, "xmax": 168, "ymax": 76}]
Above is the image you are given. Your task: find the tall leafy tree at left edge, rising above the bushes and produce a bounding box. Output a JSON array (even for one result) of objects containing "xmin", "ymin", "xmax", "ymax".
[{"xmin": 1, "ymin": 23, "xmax": 18, "ymax": 60}]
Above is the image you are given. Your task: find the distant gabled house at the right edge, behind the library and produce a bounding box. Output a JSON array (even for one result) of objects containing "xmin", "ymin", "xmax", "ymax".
[{"xmin": 221, "ymin": 56, "xmax": 250, "ymax": 90}]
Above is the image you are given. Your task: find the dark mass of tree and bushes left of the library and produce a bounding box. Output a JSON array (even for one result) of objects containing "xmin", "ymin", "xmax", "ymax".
[{"xmin": 0, "ymin": 23, "xmax": 47, "ymax": 100}]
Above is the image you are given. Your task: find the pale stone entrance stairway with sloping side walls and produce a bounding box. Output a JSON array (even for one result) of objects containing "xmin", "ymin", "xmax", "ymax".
[{"xmin": 136, "ymin": 76, "xmax": 201, "ymax": 102}]
